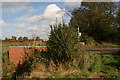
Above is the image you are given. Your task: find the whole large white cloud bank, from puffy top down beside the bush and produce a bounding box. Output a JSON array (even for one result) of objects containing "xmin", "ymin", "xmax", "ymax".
[{"xmin": 18, "ymin": 4, "xmax": 65, "ymax": 38}]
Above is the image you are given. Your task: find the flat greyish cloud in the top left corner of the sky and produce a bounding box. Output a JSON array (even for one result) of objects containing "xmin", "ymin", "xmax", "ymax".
[{"xmin": 0, "ymin": 2, "xmax": 34, "ymax": 13}]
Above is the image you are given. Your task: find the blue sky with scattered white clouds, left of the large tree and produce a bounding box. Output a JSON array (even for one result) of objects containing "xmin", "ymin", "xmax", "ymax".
[{"xmin": 0, "ymin": 2, "xmax": 80, "ymax": 39}]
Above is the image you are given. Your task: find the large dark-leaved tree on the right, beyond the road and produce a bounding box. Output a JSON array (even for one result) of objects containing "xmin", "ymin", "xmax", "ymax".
[{"xmin": 70, "ymin": 2, "xmax": 118, "ymax": 42}]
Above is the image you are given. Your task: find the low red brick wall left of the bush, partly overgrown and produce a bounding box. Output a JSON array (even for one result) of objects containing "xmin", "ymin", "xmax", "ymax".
[{"xmin": 9, "ymin": 46, "xmax": 47, "ymax": 65}]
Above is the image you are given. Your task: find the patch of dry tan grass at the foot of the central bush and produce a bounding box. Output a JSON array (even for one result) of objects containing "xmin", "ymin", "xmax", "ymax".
[{"xmin": 29, "ymin": 63, "xmax": 81, "ymax": 78}]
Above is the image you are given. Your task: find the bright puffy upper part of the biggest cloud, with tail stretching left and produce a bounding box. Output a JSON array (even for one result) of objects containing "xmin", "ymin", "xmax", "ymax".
[{"xmin": 25, "ymin": 4, "xmax": 65, "ymax": 24}]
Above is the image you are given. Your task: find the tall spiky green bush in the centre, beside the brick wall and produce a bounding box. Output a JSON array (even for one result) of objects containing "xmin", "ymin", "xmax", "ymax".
[{"xmin": 48, "ymin": 24, "xmax": 80, "ymax": 63}]
